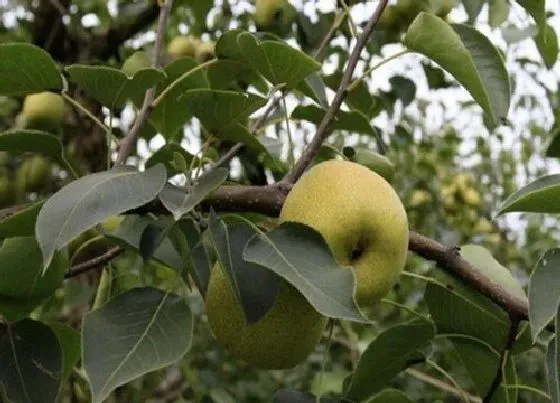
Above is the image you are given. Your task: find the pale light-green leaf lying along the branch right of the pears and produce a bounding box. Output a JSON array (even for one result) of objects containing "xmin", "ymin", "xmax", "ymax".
[{"xmin": 460, "ymin": 245, "xmax": 528, "ymax": 302}]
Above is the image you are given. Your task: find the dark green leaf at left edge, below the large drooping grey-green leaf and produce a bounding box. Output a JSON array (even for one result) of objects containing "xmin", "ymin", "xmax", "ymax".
[{"xmin": 0, "ymin": 237, "xmax": 68, "ymax": 322}]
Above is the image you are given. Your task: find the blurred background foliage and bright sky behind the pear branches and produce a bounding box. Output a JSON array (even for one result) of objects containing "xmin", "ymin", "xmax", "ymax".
[{"xmin": 0, "ymin": 0, "xmax": 560, "ymax": 403}]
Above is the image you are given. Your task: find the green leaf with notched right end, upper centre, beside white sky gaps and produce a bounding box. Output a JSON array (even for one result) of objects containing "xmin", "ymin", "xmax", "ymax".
[{"xmin": 179, "ymin": 89, "xmax": 266, "ymax": 152}]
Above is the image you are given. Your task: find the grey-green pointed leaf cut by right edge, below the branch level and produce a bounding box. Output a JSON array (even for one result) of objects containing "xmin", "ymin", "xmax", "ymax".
[{"xmin": 529, "ymin": 248, "xmax": 560, "ymax": 341}]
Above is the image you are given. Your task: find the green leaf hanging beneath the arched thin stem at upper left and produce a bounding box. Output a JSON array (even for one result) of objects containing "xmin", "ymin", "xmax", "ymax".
[{"xmin": 150, "ymin": 57, "xmax": 209, "ymax": 139}]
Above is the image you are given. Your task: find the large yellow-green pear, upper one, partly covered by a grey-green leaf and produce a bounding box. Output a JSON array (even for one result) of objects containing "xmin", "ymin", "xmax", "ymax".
[{"xmin": 280, "ymin": 160, "xmax": 408, "ymax": 308}]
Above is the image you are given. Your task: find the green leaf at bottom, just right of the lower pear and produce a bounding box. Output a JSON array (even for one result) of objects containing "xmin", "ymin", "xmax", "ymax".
[{"xmin": 344, "ymin": 320, "xmax": 435, "ymax": 401}]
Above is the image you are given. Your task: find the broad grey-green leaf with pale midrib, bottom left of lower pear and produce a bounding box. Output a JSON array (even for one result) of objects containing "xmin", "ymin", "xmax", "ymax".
[{"xmin": 82, "ymin": 287, "xmax": 193, "ymax": 403}]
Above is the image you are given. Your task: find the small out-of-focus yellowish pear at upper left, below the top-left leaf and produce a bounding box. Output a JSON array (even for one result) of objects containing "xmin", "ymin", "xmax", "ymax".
[{"xmin": 21, "ymin": 91, "xmax": 64, "ymax": 131}]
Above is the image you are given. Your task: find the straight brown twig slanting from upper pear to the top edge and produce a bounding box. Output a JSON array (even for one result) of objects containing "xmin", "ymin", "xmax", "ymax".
[{"xmin": 282, "ymin": 0, "xmax": 388, "ymax": 183}]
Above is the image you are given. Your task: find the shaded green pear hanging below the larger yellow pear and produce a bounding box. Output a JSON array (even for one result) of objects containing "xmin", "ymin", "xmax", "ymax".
[{"xmin": 205, "ymin": 264, "xmax": 327, "ymax": 369}]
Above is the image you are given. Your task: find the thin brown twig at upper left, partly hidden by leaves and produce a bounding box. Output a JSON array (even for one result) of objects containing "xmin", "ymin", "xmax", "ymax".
[{"xmin": 114, "ymin": 0, "xmax": 173, "ymax": 165}]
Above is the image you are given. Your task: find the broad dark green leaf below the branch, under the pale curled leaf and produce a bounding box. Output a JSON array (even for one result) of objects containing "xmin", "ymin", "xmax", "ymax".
[{"xmin": 424, "ymin": 270, "xmax": 510, "ymax": 351}]
